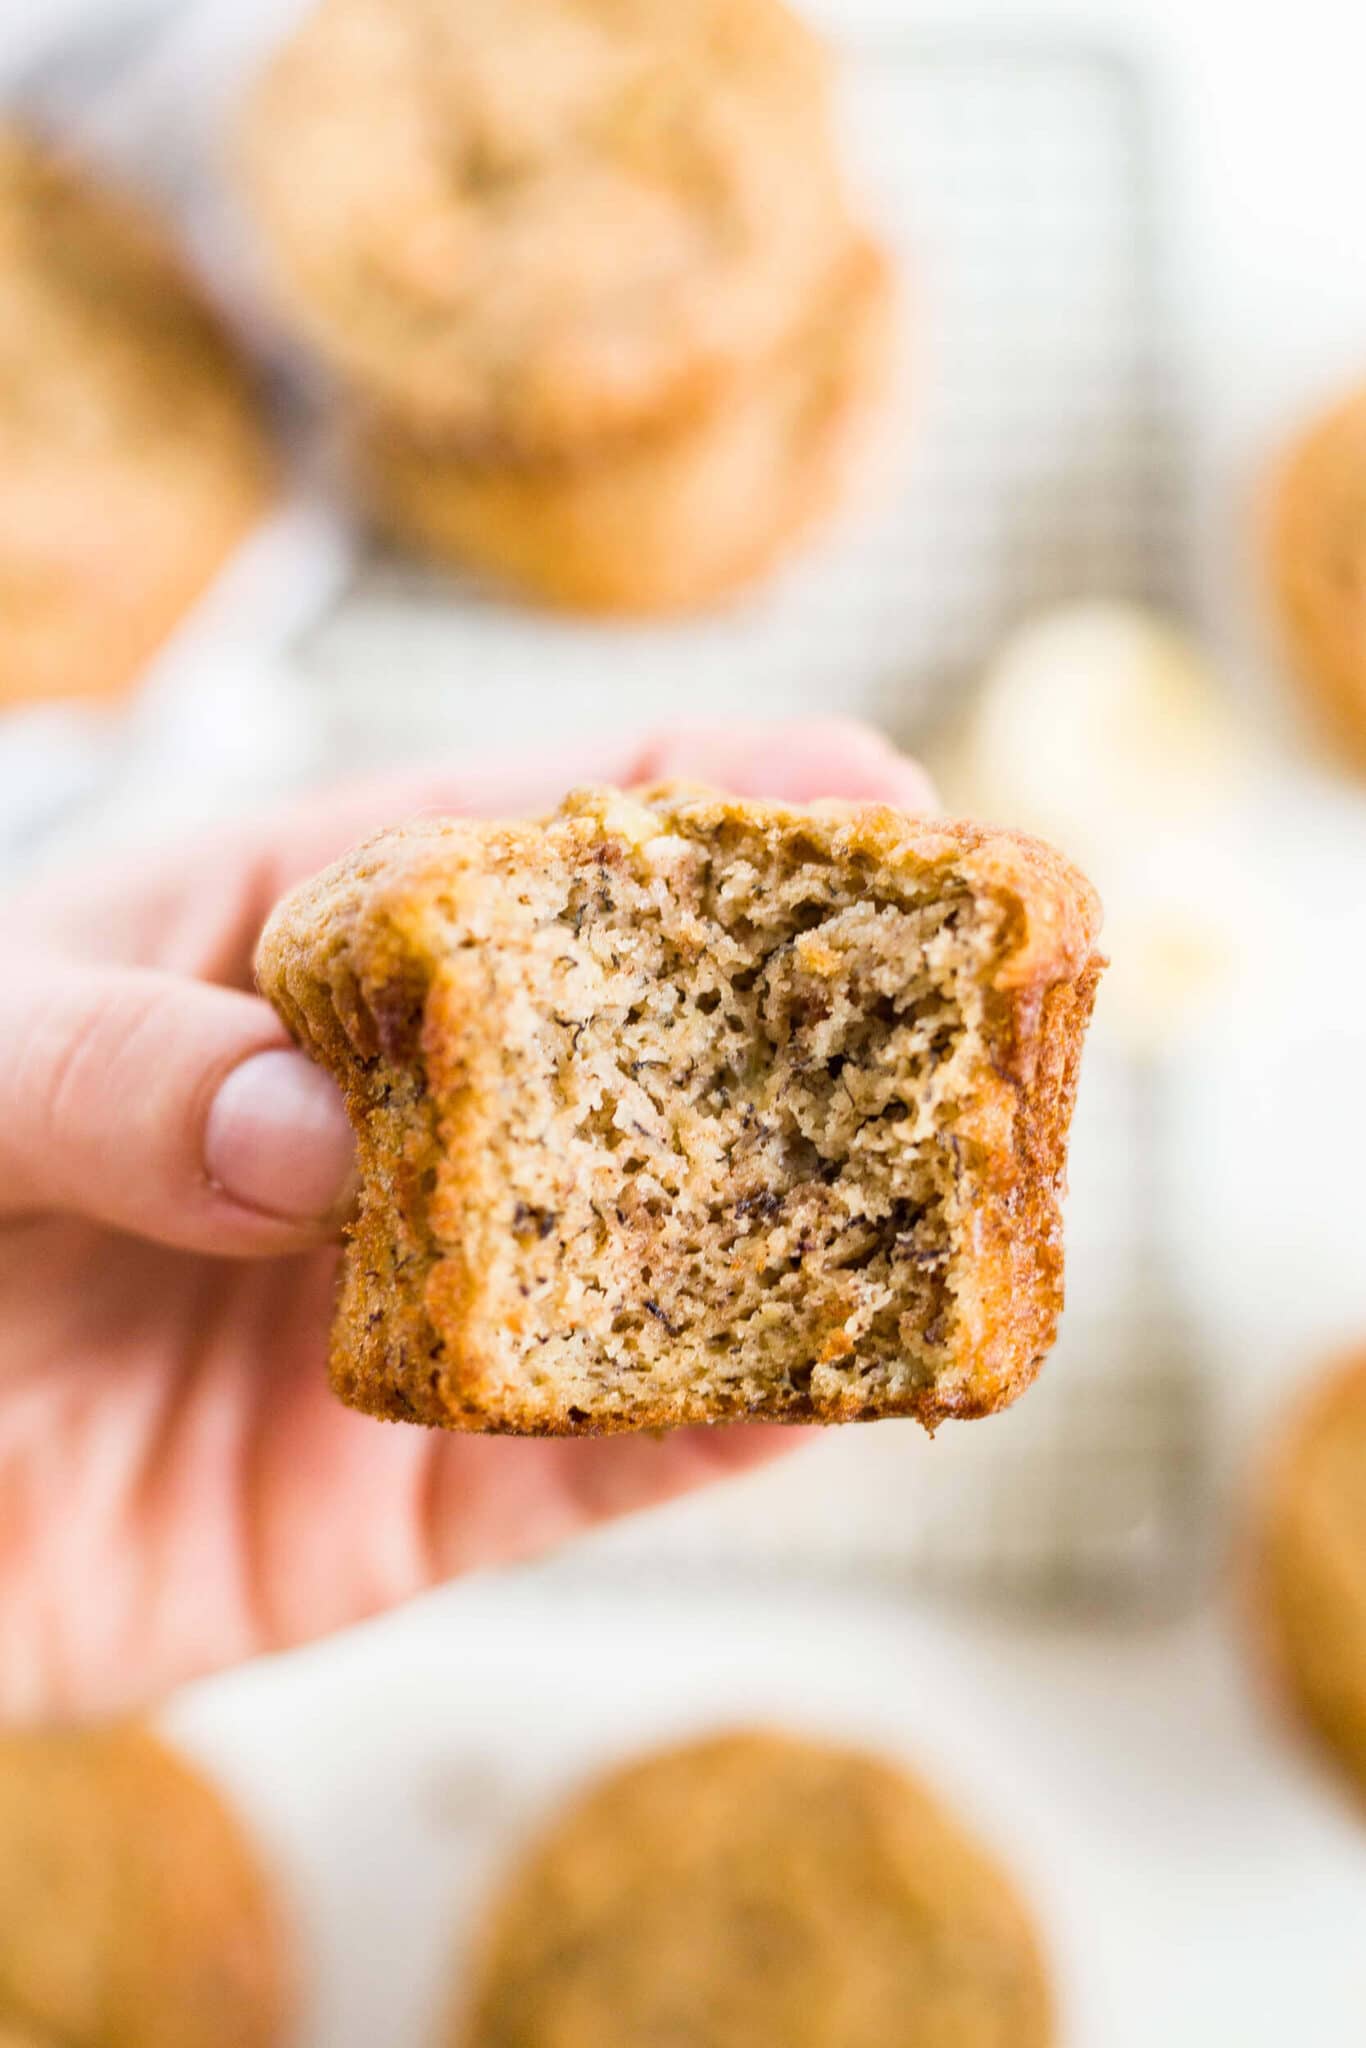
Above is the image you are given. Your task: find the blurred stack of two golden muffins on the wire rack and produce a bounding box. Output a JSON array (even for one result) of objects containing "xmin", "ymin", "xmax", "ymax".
[{"xmin": 246, "ymin": 0, "xmax": 891, "ymax": 612}]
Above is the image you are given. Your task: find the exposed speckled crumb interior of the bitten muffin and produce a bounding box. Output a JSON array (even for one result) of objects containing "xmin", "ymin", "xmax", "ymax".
[{"xmin": 350, "ymin": 821, "xmax": 1004, "ymax": 1427}]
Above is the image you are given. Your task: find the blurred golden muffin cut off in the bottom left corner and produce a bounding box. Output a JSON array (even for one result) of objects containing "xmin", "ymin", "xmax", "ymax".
[{"xmin": 0, "ymin": 1726, "xmax": 293, "ymax": 2048}]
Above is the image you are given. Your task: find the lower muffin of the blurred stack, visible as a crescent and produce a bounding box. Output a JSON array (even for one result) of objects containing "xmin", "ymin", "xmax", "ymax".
[{"xmin": 362, "ymin": 242, "xmax": 893, "ymax": 612}]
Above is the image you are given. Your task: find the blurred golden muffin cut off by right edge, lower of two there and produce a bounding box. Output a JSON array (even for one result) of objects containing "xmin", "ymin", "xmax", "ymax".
[{"xmin": 1255, "ymin": 1354, "xmax": 1366, "ymax": 1794}]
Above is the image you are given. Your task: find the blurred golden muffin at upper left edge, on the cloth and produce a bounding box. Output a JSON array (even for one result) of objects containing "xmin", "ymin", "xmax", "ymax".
[{"xmin": 0, "ymin": 127, "xmax": 272, "ymax": 705}]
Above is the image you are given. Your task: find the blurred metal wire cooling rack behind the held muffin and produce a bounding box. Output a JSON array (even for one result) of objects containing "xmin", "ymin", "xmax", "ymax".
[{"xmin": 294, "ymin": 33, "xmax": 1204, "ymax": 1610}]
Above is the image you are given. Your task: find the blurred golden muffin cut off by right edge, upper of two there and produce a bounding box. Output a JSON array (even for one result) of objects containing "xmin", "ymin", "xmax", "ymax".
[{"xmin": 1272, "ymin": 387, "xmax": 1366, "ymax": 772}]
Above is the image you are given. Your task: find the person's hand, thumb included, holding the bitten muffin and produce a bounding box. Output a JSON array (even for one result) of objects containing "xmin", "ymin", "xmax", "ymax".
[{"xmin": 0, "ymin": 725, "xmax": 932, "ymax": 1718}]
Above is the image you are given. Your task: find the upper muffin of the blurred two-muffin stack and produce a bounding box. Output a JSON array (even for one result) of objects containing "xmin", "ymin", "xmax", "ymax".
[{"xmin": 244, "ymin": 0, "xmax": 848, "ymax": 457}]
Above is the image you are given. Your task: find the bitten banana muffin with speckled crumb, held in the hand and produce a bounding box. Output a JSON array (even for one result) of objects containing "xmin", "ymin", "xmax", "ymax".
[{"xmin": 258, "ymin": 788, "xmax": 1100, "ymax": 1434}]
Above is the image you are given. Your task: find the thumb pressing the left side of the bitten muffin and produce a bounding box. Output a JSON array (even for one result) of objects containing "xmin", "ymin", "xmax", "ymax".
[{"xmin": 0, "ymin": 958, "xmax": 354, "ymax": 1255}]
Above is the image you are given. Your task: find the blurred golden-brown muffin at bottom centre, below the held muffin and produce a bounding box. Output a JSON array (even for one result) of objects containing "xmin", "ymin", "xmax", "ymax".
[{"xmin": 451, "ymin": 1733, "xmax": 1053, "ymax": 2048}]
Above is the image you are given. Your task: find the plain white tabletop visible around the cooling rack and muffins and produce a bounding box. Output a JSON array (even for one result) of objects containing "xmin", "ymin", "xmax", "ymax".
[{"xmin": 4, "ymin": 0, "xmax": 1366, "ymax": 2048}]
